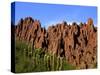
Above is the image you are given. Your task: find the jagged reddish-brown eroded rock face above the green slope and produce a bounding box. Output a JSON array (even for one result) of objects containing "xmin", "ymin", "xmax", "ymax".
[{"xmin": 16, "ymin": 17, "xmax": 97, "ymax": 69}]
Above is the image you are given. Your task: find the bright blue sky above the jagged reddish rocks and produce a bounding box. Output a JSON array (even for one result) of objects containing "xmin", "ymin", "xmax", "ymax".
[{"xmin": 12, "ymin": 2, "xmax": 97, "ymax": 27}]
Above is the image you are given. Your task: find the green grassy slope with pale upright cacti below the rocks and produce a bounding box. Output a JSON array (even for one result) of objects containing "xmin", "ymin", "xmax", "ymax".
[{"xmin": 15, "ymin": 41, "xmax": 75, "ymax": 73}]
